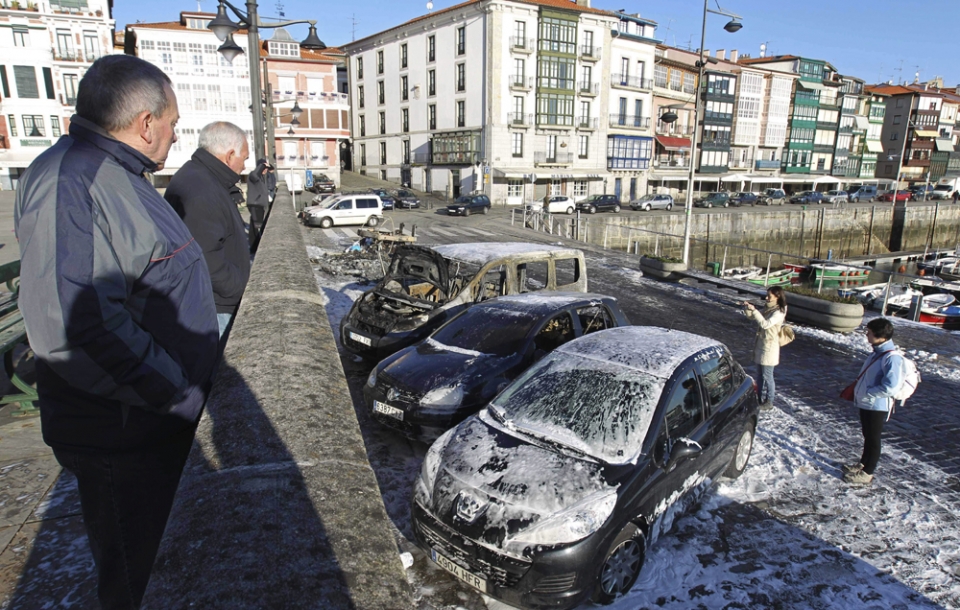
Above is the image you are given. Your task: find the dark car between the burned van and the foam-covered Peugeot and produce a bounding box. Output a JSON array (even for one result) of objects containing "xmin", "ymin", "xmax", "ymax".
[{"xmin": 363, "ymin": 292, "xmax": 629, "ymax": 442}]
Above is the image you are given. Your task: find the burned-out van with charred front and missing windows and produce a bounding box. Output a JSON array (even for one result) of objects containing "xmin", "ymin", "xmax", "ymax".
[{"xmin": 340, "ymin": 243, "xmax": 587, "ymax": 360}]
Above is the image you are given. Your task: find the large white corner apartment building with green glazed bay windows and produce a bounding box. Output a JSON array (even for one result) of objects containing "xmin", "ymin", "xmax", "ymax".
[{"xmin": 343, "ymin": 0, "xmax": 619, "ymax": 204}]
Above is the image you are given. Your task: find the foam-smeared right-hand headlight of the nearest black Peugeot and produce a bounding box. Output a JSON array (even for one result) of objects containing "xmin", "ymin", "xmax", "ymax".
[{"xmin": 504, "ymin": 490, "xmax": 617, "ymax": 555}]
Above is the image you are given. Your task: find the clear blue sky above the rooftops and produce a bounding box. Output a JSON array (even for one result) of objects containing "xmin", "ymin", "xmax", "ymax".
[{"xmin": 114, "ymin": 0, "xmax": 960, "ymax": 87}]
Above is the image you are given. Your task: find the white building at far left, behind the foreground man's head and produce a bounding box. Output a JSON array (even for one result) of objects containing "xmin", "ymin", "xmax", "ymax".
[{"xmin": 0, "ymin": 0, "xmax": 114, "ymax": 189}]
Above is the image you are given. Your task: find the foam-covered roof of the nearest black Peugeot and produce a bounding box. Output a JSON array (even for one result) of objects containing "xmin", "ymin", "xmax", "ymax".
[{"xmin": 556, "ymin": 326, "xmax": 723, "ymax": 379}]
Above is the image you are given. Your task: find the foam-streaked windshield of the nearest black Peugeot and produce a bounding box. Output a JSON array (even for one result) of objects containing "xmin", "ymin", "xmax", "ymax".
[{"xmin": 491, "ymin": 353, "xmax": 663, "ymax": 464}]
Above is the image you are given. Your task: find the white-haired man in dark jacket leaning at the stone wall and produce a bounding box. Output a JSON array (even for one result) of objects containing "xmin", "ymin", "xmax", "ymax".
[{"xmin": 164, "ymin": 121, "xmax": 250, "ymax": 337}]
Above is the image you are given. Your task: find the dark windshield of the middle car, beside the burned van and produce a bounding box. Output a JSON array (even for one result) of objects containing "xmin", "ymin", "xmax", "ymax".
[{"xmin": 431, "ymin": 306, "xmax": 539, "ymax": 356}]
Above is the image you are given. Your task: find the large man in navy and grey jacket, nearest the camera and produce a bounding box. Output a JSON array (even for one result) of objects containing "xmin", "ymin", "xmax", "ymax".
[{"xmin": 14, "ymin": 55, "xmax": 217, "ymax": 609}]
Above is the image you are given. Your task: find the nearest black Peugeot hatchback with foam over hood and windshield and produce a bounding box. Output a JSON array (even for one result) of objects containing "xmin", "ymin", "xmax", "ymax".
[{"xmin": 411, "ymin": 326, "xmax": 759, "ymax": 610}]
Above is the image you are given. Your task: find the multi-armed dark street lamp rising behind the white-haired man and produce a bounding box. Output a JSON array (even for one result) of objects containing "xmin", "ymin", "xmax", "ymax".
[{"xmin": 207, "ymin": 0, "xmax": 327, "ymax": 158}]
